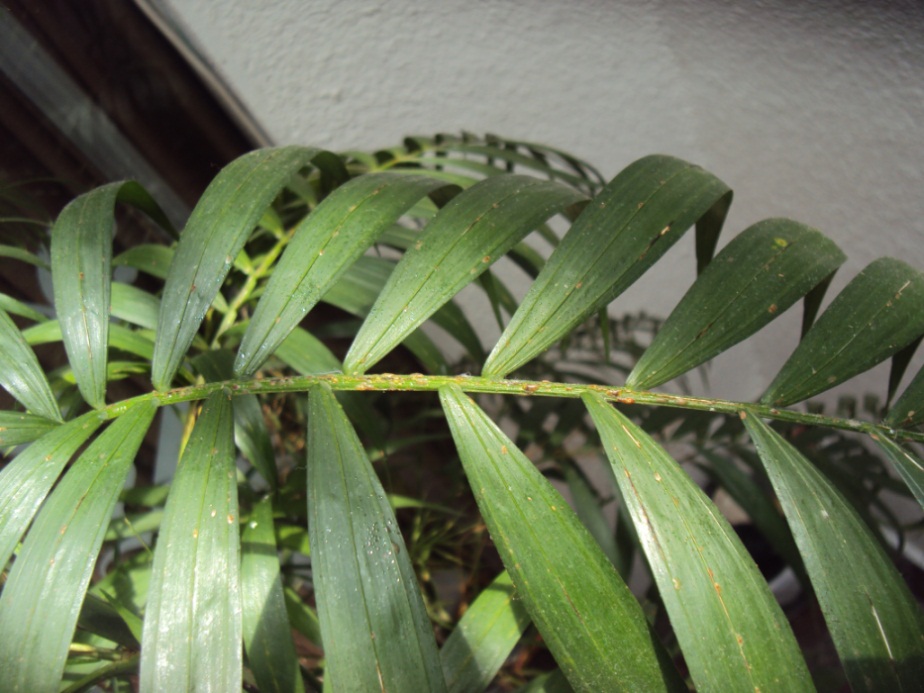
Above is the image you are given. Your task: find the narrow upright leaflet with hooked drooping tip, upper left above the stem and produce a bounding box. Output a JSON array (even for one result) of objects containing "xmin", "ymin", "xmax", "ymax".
[{"xmin": 51, "ymin": 181, "xmax": 170, "ymax": 409}]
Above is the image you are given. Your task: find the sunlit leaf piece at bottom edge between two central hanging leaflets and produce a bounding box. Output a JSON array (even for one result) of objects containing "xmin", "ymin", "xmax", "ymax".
[{"xmin": 440, "ymin": 571, "xmax": 529, "ymax": 693}]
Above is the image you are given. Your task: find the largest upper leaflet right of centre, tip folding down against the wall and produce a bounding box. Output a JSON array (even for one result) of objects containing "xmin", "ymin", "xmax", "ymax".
[{"xmin": 483, "ymin": 156, "xmax": 729, "ymax": 376}]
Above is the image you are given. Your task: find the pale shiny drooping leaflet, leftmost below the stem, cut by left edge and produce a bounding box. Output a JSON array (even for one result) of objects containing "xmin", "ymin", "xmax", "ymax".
[{"xmin": 0, "ymin": 412, "xmax": 102, "ymax": 569}]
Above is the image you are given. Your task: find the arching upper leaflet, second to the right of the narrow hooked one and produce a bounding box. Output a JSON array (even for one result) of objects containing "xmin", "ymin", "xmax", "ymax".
[{"xmin": 234, "ymin": 173, "xmax": 456, "ymax": 377}]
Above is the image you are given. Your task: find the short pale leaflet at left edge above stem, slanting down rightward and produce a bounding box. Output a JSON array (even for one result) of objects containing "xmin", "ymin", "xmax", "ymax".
[{"xmin": 0, "ymin": 310, "xmax": 62, "ymax": 421}]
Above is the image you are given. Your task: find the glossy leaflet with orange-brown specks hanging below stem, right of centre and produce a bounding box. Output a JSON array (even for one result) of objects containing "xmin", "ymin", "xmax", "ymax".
[{"xmin": 583, "ymin": 395, "xmax": 813, "ymax": 691}]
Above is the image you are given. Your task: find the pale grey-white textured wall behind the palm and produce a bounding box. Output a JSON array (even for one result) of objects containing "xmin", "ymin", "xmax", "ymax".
[{"xmin": 159, "ymin": 0, "xmax": 924, "ymax": 397}]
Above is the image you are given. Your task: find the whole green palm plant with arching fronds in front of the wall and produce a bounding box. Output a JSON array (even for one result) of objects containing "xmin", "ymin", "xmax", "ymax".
[{"xmin": 0, "ymin": 135, "xmax": 924, "ymax": 691}]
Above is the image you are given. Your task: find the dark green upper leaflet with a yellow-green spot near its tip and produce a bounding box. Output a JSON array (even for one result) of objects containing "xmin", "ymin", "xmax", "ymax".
[{"xmin": 626, "ymin": 219, "xmax": 846, "ymax": 390}]
